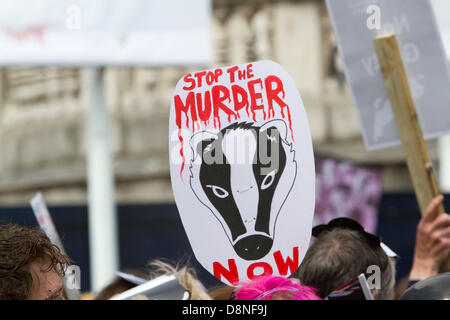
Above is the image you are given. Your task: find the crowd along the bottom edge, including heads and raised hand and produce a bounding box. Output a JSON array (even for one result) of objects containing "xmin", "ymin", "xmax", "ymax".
[{"xmin": 0, "ymin": 195, "xmax": 450, "ymax": 300}]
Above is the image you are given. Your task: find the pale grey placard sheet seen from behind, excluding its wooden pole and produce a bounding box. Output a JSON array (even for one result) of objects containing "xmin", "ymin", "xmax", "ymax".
[{"xmin": 327, "ymin": 0, "xmax": 450, "ymax": 150}]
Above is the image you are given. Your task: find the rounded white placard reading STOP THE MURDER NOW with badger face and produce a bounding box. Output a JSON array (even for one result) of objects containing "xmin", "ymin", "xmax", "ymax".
[{"xmin": 169, "ymin": 61, "xmax": 315, "ymax": 283}]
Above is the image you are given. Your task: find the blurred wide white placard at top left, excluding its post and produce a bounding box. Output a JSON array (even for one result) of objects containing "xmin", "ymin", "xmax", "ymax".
[{"xmin": 0, "ymin": 0, "xmax": 212, "ymax": 66}]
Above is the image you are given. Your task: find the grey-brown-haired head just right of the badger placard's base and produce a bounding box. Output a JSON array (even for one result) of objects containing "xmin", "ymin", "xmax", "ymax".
[{"xmin": 295, "ymin": 219, "xmax": 395, "ymax": 300}]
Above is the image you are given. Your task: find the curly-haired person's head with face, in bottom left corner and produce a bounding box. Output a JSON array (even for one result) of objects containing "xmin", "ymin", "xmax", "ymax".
[{"xmin": 0, "ymin": 223, "xmax": 70, "ymax": 300}]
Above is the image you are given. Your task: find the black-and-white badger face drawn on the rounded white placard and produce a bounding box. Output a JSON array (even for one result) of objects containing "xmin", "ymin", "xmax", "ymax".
[{"xmin": 189, "ymin": 120, "xmax": 297, "ymax": 260}]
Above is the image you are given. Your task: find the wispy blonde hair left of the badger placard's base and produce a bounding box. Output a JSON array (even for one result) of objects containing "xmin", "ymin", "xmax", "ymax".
[{"xmin": 149, "ymin": 260, "xmax": 212, "ymax": 300}]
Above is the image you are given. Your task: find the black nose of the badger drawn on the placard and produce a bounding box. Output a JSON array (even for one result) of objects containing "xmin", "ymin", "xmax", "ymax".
[{"xmin": 233, "ymin": 234, "xmax": 273, "ymax": 260}]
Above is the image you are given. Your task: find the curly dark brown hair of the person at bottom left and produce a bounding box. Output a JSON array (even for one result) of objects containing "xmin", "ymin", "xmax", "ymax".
[{"xmin": 0, "ymin": 223, "xmax": 70, "ymax": 300}]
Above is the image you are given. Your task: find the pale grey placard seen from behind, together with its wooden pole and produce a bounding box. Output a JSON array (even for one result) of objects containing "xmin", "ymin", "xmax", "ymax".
[{"xmin": 327, "ymin": 0, "xmax": 450, "ymax": 271}]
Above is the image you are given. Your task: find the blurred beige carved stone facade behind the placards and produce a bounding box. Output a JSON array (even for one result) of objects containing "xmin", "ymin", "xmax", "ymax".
[{"xmin": 0, "ymin": 0, "xmax": 422, "ymax": 206}]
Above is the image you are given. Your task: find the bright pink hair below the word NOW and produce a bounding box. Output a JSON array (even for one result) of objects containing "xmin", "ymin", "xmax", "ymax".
[{"xmin": 236, "ymin": 276, "xmax": 322, "ymax": 300}]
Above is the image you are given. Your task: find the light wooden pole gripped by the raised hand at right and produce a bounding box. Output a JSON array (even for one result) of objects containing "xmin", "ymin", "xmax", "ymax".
[{"xmin": 374, "ymin": 34, "xmax": 450, "ymax": 271}]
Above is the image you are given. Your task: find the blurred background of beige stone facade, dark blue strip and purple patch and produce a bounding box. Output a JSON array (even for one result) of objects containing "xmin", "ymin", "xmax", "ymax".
[{"xmin": 0, "ymin": 0, "xmax": 450, "ymax": 291}]
